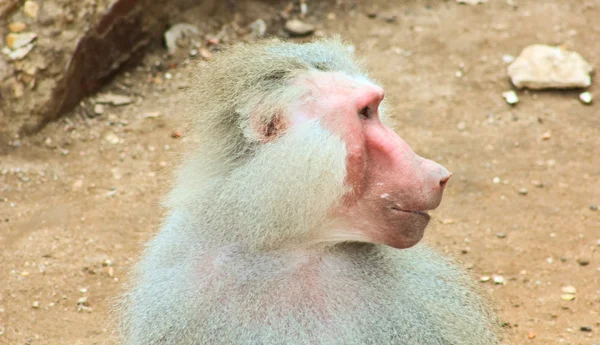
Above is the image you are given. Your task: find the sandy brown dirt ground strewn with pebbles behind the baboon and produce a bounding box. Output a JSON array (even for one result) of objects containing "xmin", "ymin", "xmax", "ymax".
[{"xmin": 0, "ymin": 0, "xmax": 600, "ymax": 345}]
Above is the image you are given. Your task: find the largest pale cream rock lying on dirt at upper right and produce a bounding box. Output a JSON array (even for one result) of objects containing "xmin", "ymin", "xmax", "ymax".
[{"xmin": 508, "ymin": 44, "xmax": 593, "ymax": 90}]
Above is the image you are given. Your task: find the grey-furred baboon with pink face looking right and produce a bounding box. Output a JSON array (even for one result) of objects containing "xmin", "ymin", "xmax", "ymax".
[{"xmin": 119, "ymin": 38, "xmax": 500, "ymax": 345}]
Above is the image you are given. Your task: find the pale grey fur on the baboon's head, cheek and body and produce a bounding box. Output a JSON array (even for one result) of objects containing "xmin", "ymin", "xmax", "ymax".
[{"xmin": 119, "ymin": 40, "xmax": 498, "ymax": 345}]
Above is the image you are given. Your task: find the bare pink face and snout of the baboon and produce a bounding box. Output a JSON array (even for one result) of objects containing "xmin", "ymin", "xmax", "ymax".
[{"xmin": 292, "ymin": 72, "xmax": 452, "ymax": 248}]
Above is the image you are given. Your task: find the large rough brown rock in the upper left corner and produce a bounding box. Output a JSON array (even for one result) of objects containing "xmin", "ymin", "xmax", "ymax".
[{"xmin": 0, "ymin": 0, "xmax": 208, "ymax": 137}]
